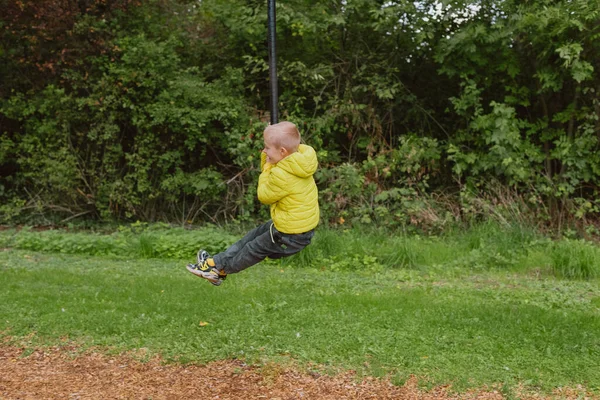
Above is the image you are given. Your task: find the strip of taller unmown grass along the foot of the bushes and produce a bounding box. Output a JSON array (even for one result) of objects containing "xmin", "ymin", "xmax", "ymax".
[{"xmin": 0, "ymin": 222, "xmax": 600, "ymax": 279}]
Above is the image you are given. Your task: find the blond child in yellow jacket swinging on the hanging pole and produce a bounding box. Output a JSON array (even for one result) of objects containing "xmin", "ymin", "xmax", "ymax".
[{"xmin": 187, "ymin": 122, "xmax": 319, "ymax": 286}]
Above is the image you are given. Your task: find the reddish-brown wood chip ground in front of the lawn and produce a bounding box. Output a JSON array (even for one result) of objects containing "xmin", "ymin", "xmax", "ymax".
[{"xmin": 0, "ymin": 347, "xmax": 591, "ymax": 400}]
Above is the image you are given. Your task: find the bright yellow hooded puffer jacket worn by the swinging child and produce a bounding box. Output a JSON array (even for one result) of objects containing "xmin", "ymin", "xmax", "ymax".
[{"xmin": 258, "ymin": 144, "xmax": 319, "ymax": 233}]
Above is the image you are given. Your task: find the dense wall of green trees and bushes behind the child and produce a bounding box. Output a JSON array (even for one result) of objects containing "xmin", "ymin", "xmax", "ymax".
[{"xmin": 0, "ymin": 0, "xmax": 600, "ymax": 236}]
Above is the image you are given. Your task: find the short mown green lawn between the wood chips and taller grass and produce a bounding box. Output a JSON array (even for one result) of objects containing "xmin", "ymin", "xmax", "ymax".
[{"xmin": 0, "ymin": 228, "xmax": 600, "ymax": 392}]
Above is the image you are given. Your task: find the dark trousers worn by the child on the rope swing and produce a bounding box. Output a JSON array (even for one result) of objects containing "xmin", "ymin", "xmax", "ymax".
[{"xmin": 213, "ymin": 221, "xmax": 315, "ymax": 274}]
